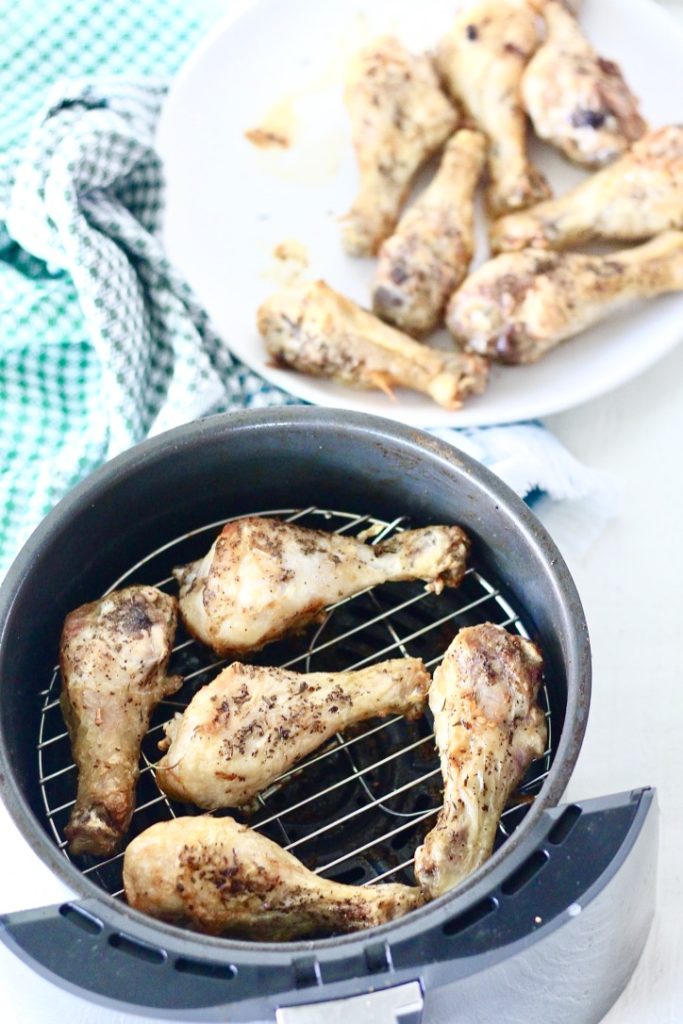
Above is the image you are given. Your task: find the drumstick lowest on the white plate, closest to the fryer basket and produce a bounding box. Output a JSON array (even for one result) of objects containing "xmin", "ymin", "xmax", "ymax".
[{"xmin": 258, "ymin": 281, "xmax": 488, "ymax": 410}]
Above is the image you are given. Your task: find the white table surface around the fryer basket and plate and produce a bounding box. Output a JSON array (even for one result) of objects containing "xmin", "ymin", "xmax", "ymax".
[{"xmin": 0, "ymin": 0, "xmax": 683, "ymax": 1024}]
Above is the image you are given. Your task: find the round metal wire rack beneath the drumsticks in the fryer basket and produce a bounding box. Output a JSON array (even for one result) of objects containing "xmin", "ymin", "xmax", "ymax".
[{"xmin": 38, "ymin": 507, "xmax": 553, "ymax": 909}]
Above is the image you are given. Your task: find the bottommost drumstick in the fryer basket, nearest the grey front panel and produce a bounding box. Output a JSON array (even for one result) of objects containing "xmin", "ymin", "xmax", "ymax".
[{"xmin": 123, "ymin": 815, "xmax": 424, "ymax": 942}]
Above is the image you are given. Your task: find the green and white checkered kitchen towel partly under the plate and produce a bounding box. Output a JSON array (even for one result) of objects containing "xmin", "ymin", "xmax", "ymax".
[{"xmin": 0, "ymin": 0, "xmax": 610, "ymax": 577}]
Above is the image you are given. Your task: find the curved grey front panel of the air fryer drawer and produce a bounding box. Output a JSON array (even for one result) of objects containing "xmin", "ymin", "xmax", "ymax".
[{"xmin": 0, "ymin": 790, "xmax": 657, "ymax": 1024}]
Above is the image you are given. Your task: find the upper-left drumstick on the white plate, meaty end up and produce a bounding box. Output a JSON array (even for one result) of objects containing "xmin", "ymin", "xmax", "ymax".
[{"xmin": 344, "ymin": 36, "xmax": 459, "ymax": 256}]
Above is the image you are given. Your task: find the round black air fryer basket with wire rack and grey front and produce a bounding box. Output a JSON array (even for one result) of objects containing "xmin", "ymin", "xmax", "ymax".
[{"xmin": 0, "ymin": 409, "xmax": 656, "ymax": 1024}]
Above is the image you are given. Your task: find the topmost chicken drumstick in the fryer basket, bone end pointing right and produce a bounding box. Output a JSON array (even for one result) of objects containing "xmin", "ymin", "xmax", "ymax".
[{"xmin": 174, "ymin": 516, "xmax": 469, "ymax": 655}]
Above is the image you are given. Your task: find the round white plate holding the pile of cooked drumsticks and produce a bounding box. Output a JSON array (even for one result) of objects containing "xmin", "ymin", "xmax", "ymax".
[{"xmin": 158, "ymin": 0, "xmax": 683, "ymax": 427}]
